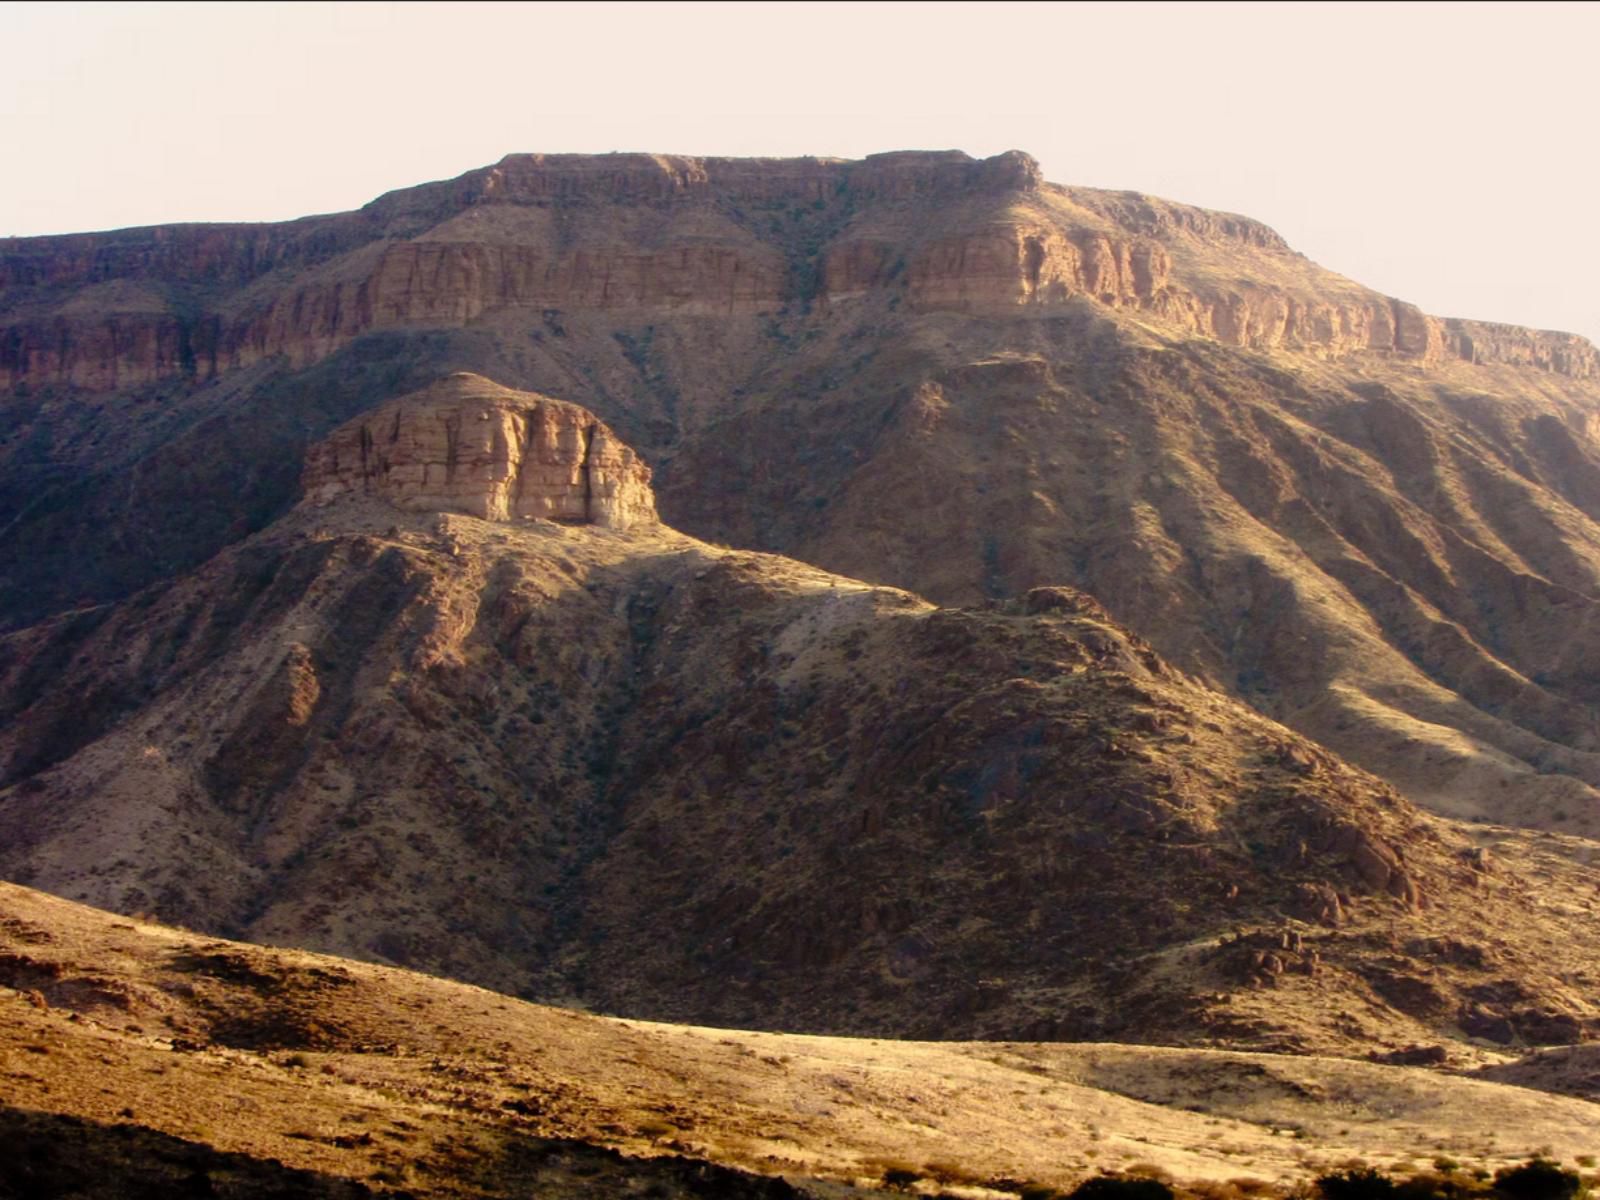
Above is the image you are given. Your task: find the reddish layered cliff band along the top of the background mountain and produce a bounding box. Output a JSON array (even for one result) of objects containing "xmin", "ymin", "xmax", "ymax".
[{"xmin": 0, "ymin": 152, "xmax": 1597, "ymax": 390}]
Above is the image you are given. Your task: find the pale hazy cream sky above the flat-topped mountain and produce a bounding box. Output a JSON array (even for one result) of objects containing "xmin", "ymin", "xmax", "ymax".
[{"xmin": 9, "ymin": 0, "xmax": 1600, "ymax": 338}]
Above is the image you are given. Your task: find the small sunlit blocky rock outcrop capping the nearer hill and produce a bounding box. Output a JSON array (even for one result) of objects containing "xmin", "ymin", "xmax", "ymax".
[{"xmin": 304, "ymin": 371, "xmax": 656, "ymax": 530}]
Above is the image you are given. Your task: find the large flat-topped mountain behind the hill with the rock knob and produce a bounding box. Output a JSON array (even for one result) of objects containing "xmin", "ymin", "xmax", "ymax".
[{"xmin": 0, "ymin": 152, "xmax": 1600, "ymax": 838}]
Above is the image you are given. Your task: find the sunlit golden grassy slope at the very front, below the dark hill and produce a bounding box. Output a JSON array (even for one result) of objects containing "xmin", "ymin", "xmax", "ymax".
[{"xmin": 0, "ymin": 885, "xmax": 1600, "ymax": 1200}]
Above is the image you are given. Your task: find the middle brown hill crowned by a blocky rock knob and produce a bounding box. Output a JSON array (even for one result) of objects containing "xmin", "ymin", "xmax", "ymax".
[{"xmin": 0, "ymin": 376, "xmax": 1600, "ymax": 1058}]
